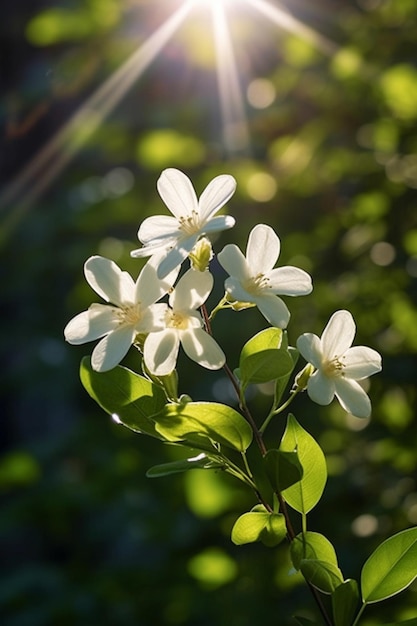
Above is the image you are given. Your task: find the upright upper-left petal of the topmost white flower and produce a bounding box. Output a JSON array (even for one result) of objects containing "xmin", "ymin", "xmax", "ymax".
[{"xmin": 157, "ymin": 168, "xmax": 198, "ymax": 219}]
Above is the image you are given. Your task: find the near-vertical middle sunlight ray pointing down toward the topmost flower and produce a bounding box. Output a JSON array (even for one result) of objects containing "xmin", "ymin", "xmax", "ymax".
[{"xmin": 212, "ymin": 3, "xmax": 249, "ymax": 154}]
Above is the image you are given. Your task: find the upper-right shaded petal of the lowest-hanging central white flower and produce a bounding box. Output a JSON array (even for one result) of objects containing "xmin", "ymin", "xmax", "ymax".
[{"xmin": 169, "ymin": 269, "xmax": 214, "ymax": 311}]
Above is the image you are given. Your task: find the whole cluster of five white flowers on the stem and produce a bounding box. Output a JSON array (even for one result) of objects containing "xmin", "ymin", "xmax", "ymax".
[{"xmin": 64, "ymin": 168, "xmax": 381, "ymax": 417}]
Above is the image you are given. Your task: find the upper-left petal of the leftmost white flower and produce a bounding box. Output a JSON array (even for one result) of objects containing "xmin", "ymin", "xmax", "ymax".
[{"xmin": 84, "ymin": 256, "xmax": 135, "ymax": 306}]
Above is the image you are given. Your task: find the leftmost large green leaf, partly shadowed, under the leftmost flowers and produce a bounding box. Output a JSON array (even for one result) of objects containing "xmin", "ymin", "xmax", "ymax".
[{"xmin": 80, "ymin": 357, "xmax": 166, "ymax": 439}]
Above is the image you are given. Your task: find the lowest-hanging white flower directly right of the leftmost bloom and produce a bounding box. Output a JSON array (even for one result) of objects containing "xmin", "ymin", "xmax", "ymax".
[{"xmin": 143, "ymin": 269, "xmax": 225, "ymax": 376}]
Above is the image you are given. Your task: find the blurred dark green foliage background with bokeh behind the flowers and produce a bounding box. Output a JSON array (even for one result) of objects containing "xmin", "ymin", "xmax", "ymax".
[{"xmin": 0, "ymin": 0, "xmax": 417, "ymax": 626}]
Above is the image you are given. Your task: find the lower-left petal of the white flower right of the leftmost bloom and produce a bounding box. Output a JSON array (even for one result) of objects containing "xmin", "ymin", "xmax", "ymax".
[{"xmin": 143, "ymin": 328, "xmax": 180, "ymax": 376}]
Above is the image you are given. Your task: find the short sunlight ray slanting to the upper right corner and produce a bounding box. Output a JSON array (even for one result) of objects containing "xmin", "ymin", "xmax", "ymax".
[{"xmin": 246, "ymin": 0, "xmax": 339, "ymax": 55}]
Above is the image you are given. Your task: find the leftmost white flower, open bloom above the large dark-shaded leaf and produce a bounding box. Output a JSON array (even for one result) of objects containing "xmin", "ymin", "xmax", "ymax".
[{"xmin": 64, "ymin": 256, "xmax": 178, "ymax": 372}]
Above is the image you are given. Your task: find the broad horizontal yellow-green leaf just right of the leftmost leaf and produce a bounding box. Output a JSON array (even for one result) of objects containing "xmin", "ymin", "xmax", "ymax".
[{"xmin": 153, "ymin": 402, "xmax": 253, "ymax": 452}]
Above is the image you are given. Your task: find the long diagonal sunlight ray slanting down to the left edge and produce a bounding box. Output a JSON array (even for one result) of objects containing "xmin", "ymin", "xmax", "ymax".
[{"xmin": 0, "ymin": 0, "xmax": 193, "ymax": 236}]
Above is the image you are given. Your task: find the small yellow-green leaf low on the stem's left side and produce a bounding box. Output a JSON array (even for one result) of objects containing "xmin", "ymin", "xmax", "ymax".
[{"xmin": 232, "ymin": 506, "xmax": 287, "ymax": 547}]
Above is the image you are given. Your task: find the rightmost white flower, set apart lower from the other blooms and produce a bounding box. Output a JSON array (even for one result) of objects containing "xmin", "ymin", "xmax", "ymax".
[{"xmin": 297, "ymin": 311, "xmax": 381, "ymax": 417}]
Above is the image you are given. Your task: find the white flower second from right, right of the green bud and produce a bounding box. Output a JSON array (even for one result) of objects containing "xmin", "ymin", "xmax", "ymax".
[{"xmin": 218, "ymin": 224, "xmax": 313, "ymax": 328}]
